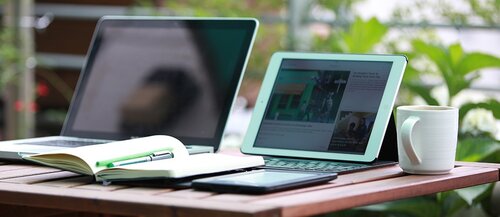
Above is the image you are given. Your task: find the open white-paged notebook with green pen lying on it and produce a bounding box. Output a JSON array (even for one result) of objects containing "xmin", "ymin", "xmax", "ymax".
[{"xmin": 23, "ymin": 136, "xmax": 264, "ymax": 181}]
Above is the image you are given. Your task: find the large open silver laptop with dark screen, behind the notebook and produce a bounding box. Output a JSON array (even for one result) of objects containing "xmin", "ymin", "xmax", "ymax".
[{"xmin": 0, "ymin": 16, "xmax": 258, "ymax": 159}]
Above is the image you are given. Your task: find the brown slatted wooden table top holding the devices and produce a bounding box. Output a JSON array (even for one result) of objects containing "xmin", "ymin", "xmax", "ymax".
[{"xmin": 0, "ymin": 162, "xmax": 500, "ymax": 216}]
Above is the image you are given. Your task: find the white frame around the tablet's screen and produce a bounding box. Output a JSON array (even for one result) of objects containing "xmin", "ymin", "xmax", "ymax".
[{"xmin": 241, "ymin": 52, "xmax": 407, "ymax": 162}]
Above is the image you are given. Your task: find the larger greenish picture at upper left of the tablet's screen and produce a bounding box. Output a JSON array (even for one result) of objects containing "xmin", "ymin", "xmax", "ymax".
[{"xmin": 265, "ymin": 70, "xmax": 349, "ymax": 123}]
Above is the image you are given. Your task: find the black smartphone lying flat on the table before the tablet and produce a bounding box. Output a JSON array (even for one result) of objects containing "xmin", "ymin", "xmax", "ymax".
[{"xmin": 191, "ymin": 169, "xmax": 337, "ymax": 194}]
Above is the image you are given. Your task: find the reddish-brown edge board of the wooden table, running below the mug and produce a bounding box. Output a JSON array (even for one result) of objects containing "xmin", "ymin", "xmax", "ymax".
[{"xmin": 251, "ymin": 167, "xmax": 499, "ymax": 216}]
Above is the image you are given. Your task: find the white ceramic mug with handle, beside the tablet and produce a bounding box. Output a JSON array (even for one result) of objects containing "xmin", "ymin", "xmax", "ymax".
[{"xmin": 396, "ymin": 106, "xmax": 458, "ymax": 174}]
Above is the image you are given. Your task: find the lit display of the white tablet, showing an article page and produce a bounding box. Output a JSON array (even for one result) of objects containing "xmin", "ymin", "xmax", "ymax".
[{"xmin": 254, "ymin": 59, "xmax": 392, "ymax": 154}]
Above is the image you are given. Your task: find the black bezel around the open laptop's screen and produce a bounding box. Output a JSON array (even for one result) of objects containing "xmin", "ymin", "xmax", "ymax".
[{"xmin": 61, "ymin": 16, "xmax": 259, "ymax": 151}]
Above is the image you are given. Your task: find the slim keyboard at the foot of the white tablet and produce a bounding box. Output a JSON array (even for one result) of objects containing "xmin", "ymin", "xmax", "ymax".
[{"xmin": 264, "ymin": 158, "xmax": 372, "ymax": 173}]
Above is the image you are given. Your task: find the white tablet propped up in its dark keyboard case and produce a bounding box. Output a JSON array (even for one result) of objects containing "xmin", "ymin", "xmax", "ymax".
[{"xmin": 241, "ymin": 52, "xmax": 407, "ymax": 174}]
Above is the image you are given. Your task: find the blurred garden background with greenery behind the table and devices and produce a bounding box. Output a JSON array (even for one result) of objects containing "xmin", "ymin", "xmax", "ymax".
[{"xmin": 0, "ymin": 0, "xmax": 500, "ymax": 216}]
